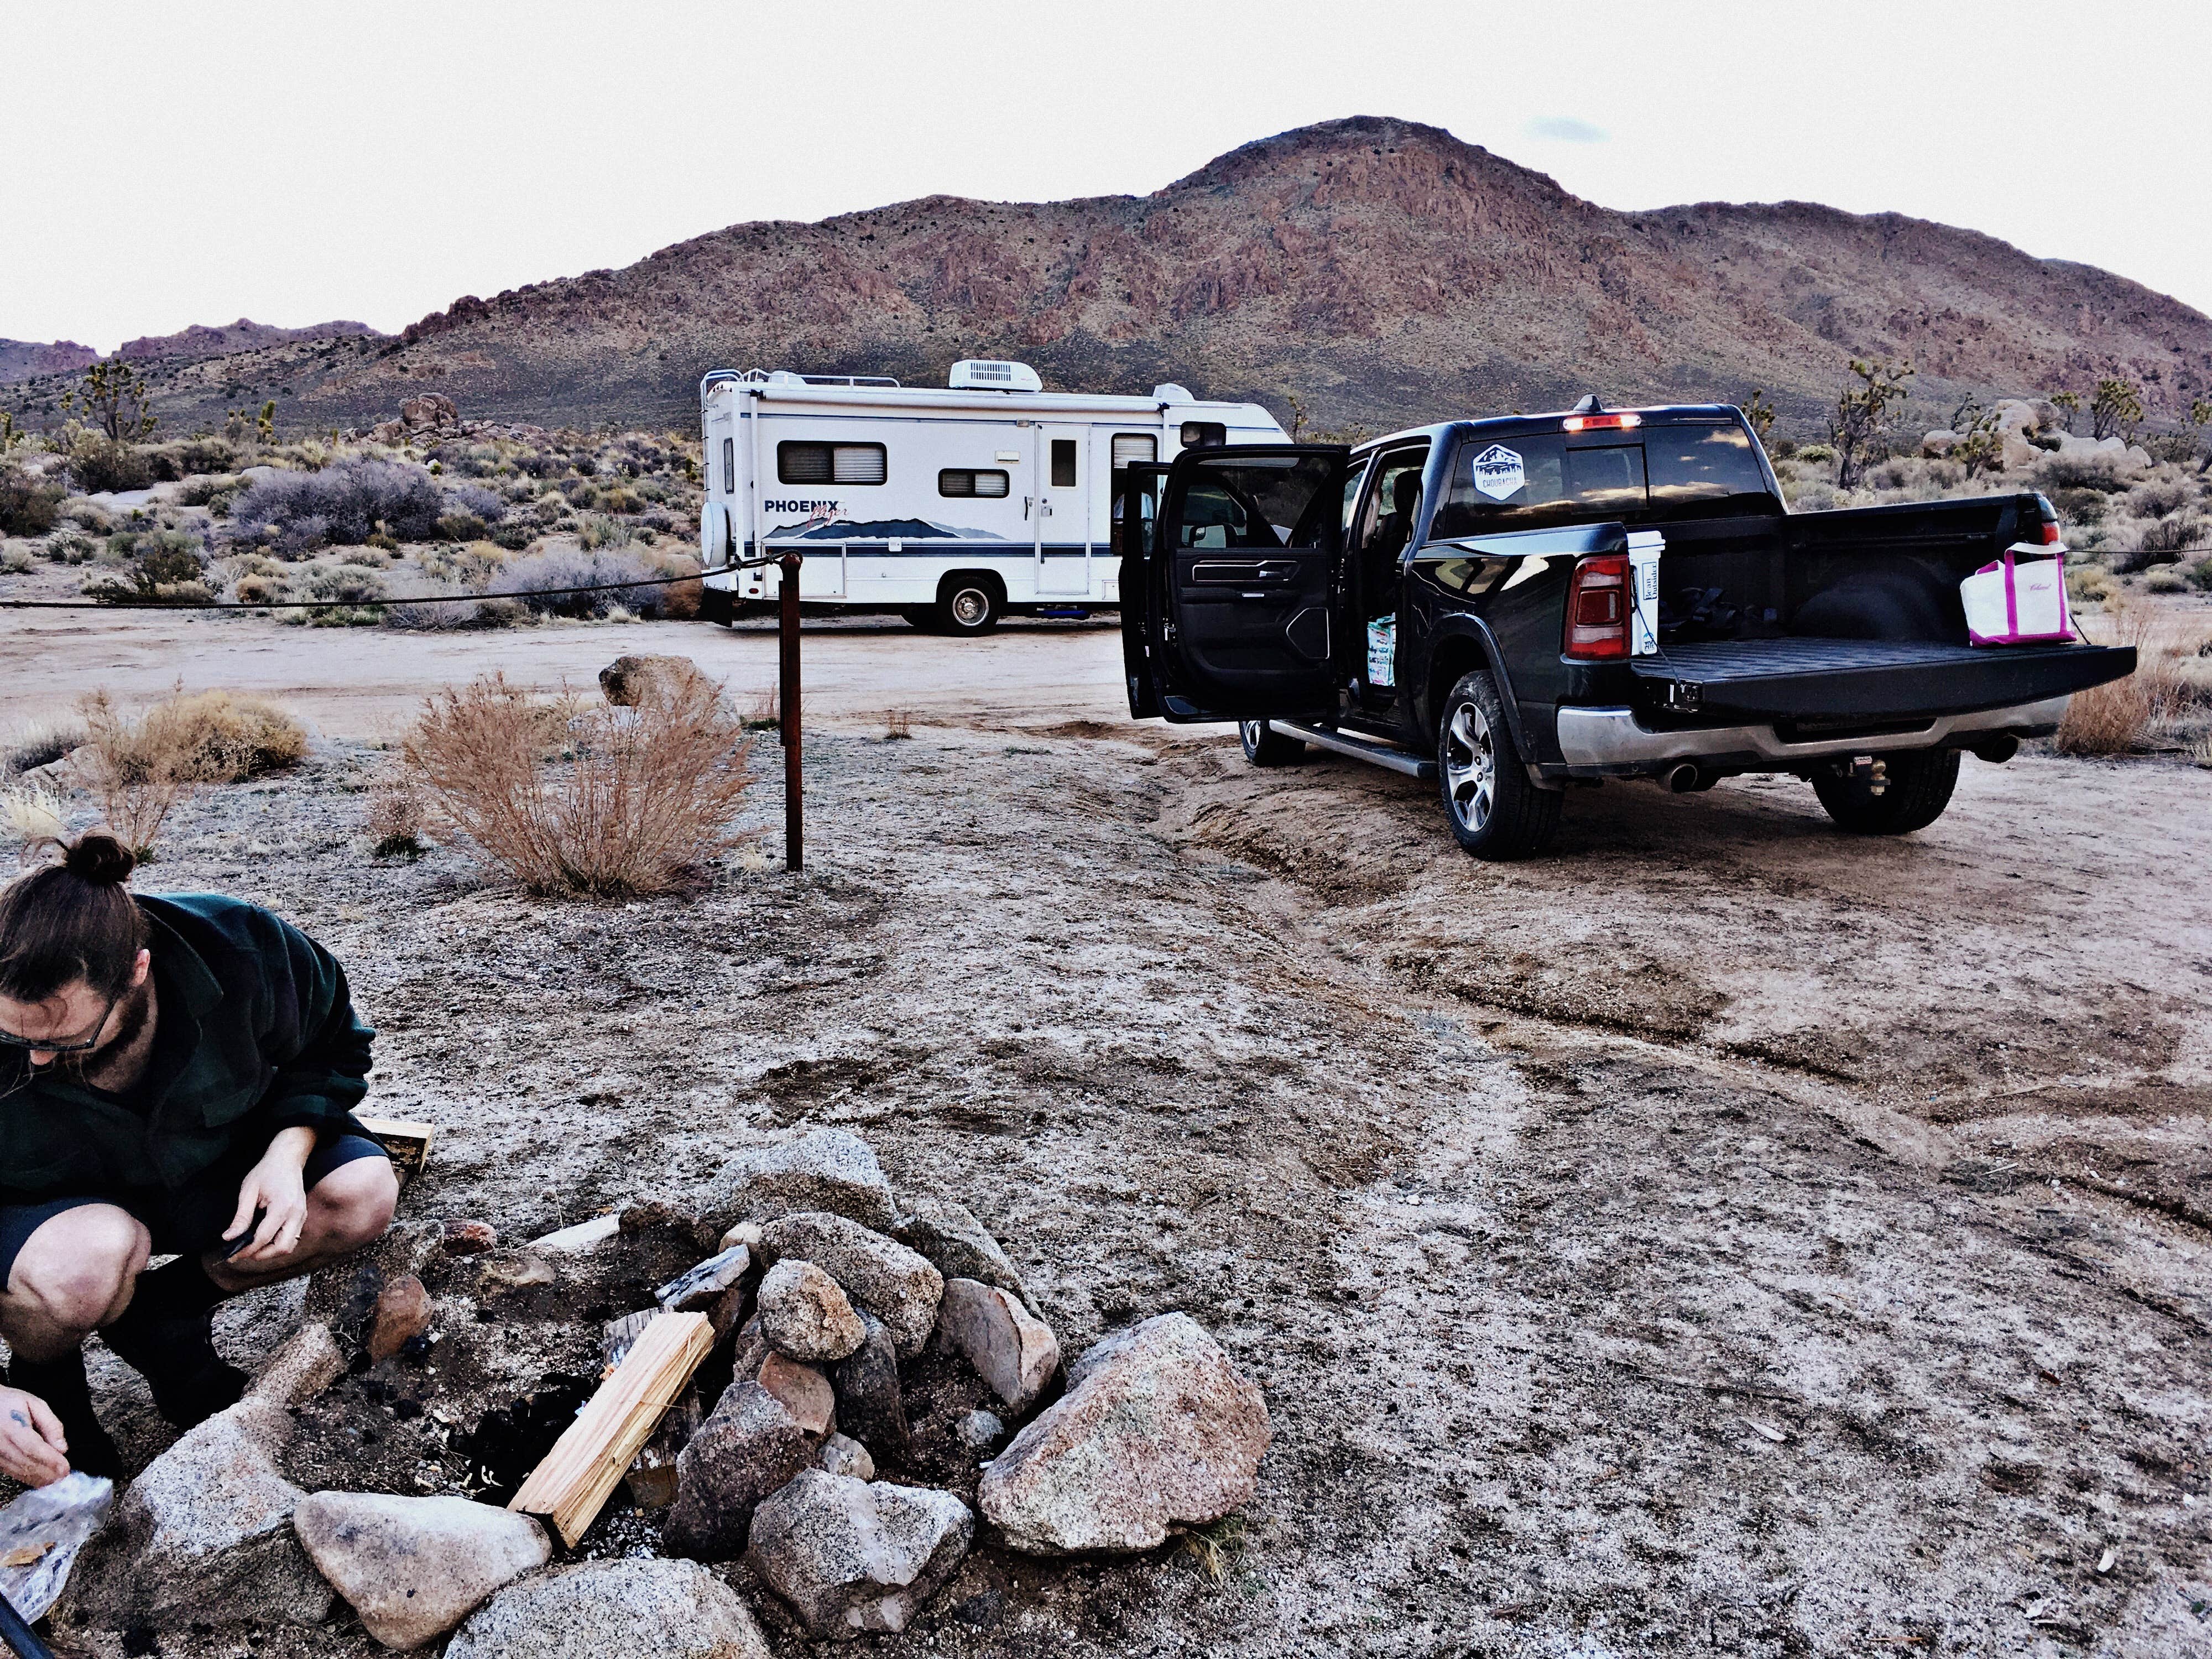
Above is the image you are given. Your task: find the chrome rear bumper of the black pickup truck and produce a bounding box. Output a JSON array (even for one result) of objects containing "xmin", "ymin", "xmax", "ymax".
[{"xmin": 1559, "ymin": 697, "xmax": 2068, "ymax": 776}]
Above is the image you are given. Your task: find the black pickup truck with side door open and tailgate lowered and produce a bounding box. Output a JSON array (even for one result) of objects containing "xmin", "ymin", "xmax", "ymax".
[{"xmin": 1119, "ymin": 398, "xmax": 2135, "ymax": 858}]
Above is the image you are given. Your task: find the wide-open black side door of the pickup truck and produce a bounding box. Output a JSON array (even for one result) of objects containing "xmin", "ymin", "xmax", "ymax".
[{"xmin": 1121, "ymin": 445, "xmax": 1349, "ymax": 723}]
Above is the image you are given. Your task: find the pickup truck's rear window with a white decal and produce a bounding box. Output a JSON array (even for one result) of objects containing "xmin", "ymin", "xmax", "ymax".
[{"xmin": 1429, "ymin": 422, "xmax": 1778, "ymax": 540}]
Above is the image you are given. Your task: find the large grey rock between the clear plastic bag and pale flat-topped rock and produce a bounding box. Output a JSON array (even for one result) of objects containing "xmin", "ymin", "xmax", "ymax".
[{"xmin": 82, "ymin": 1396, "xmax": 334, "ymax": 1626}]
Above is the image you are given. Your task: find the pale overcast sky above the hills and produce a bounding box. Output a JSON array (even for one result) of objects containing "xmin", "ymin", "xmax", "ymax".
[{"xmin": 17, "ymin": 0, "xmax": 2212, "ymax": 349}]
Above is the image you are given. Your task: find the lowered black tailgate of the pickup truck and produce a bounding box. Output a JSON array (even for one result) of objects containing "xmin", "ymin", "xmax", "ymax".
[{"xmin": 1630, "ymin": 639, "xmax": 2135, "ymax": 723}]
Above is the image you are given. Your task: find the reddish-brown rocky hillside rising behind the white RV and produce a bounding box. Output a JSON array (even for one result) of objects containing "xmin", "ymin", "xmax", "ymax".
[{"xmin": 15, "ymin": 117, "xmax": 2212, "ymax": 429}]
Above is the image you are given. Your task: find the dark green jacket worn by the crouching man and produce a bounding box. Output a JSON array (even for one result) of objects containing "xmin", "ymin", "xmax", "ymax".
[{"xmin": 0, "ymin": 894, "xmax": 376, "ymax": 1203}]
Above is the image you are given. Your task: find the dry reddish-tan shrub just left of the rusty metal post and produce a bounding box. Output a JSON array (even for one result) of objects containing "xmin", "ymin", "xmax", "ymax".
[{"xmin": 403, "ymin": 675, "xmax": 752, "ymax": 898}]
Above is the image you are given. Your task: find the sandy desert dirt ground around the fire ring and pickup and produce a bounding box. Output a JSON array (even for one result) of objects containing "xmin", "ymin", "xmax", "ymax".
[{"xmin": 13, "ymin": 617, "xmax": 2212, "ymax": 1657}]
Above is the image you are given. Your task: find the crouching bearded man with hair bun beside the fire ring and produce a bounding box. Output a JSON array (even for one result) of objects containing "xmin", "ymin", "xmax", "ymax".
[{"xmin": 0, "ymin": 832, "xmax": 398, "ymax": 1484}]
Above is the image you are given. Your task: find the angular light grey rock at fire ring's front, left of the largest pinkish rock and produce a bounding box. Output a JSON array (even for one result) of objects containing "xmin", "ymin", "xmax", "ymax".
[{"xmin": 745, "ymin": 1469, "xmax": 975, "ymax": 1637}]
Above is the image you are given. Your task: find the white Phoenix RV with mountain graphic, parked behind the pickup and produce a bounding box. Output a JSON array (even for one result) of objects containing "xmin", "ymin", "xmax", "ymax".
[{"xmin": 699, "ymin": 361, "xmax": 1283, "ymax": 635}]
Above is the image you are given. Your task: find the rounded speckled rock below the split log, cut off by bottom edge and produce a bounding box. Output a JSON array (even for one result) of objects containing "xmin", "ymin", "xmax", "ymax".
[{"xmin": 445, "ymin": 1557, "xmax": 772, "ymax": 1659}]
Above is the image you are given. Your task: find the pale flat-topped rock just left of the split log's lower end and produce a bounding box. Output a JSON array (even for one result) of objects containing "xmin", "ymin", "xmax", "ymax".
[{"xmin": 292, "ymin": 1491, "xmax": 553, "ymax": 1648}]
